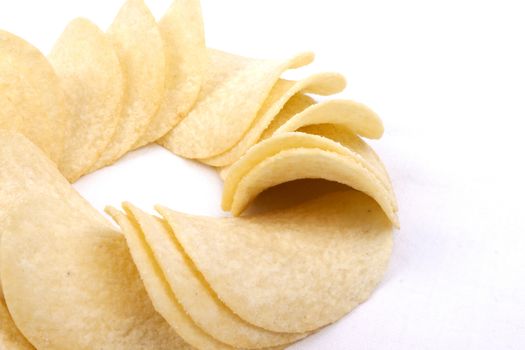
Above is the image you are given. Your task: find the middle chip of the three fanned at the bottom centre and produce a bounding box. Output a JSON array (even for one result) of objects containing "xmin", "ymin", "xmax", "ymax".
[{"xmin": 124, "ymin": 203, "xmax": 307, "ymax": 349}]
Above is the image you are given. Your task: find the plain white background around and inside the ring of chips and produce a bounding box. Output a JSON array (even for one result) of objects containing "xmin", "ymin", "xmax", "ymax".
[{"xmin": 0, "ymin": 0, "xmax": 525, "ymax": 350}]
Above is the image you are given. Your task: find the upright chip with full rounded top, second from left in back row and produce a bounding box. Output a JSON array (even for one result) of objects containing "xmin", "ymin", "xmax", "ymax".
[{"xmin": 48, "ymin": 18, "xmax": 124, "ymax": 182}]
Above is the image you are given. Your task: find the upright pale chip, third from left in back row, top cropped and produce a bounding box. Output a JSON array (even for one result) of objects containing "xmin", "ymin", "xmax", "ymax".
[{"xmin": 91, "ymin": 0, "xmax": 166, "ymax": 170}]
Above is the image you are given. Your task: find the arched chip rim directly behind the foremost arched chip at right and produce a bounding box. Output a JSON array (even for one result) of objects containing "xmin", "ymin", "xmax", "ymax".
[{"xmin": 222, "ymin": 131, "xmax": 397, "ymax": 213}]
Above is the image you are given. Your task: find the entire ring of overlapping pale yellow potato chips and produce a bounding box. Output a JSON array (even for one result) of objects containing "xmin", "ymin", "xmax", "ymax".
[{"xmin": 0, "ymin": 0, "xmax": 399, "ymax": 350}]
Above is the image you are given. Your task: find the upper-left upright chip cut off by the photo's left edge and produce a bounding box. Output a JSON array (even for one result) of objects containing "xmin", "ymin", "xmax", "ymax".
[{"xmin": 0, "ymin": 30, "xmax": 69, "ymax": 163}]
